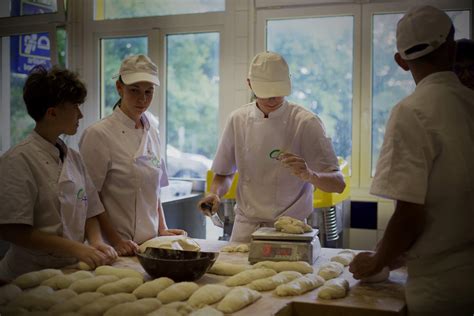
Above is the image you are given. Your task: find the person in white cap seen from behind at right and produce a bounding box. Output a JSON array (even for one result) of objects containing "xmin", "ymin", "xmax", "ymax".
[{"xmin": 349, "ymin": 6, "xmax": 474, "ymax": 315}]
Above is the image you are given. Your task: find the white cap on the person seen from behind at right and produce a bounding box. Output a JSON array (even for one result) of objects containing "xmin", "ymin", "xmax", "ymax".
[{"xmin": 397, "ymin": 5, "xmax": 453, "ymax": 60}]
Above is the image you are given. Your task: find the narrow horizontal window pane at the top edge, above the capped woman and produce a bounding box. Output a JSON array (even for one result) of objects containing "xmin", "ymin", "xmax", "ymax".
[{"xmin": 94, "ymin": 0, "xmax": 225, "ymax": 20}]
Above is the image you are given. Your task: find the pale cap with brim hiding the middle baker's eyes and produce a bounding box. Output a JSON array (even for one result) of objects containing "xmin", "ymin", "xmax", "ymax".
[{"xmin": 248, "ymin": 52, "xmax": 291, "ymax": 98}]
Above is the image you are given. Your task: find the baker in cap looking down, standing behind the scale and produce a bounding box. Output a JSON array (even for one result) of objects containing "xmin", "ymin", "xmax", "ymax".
[{"xmin": 198, "ymin": 52, "xmax": 345, "ymax": 242}]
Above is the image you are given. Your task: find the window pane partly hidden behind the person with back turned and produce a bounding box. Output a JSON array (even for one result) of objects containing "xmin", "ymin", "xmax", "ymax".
[{"xmin": 372, "ymin": 11, "xmax": 470, "ymax": 176}]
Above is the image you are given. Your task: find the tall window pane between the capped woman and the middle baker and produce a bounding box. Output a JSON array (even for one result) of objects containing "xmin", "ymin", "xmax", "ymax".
[{"xmin": 166, "ymin": 33, "xmax": 219, "ymax": 178}]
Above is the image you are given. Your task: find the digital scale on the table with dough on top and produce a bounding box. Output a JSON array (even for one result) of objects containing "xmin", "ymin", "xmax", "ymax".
[{"xmin": 249, "ymin": 227, "xmax": 321, "ymax": 265}]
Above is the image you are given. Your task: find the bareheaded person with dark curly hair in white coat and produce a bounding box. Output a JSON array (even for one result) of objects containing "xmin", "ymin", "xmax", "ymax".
[{"xmin": 0, "ymin": 67, "xmax": 117, "ymax": 280}]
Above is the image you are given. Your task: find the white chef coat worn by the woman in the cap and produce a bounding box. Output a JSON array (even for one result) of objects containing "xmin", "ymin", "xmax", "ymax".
[{"xmin": 79, "ymin": 107, "xmax": 168, "ymax": 244}]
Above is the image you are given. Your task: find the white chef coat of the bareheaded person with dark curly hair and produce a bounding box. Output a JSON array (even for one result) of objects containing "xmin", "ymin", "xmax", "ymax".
[{"xmin": 0, "ymin": 131, "xmax": 104, "ymax": 279}]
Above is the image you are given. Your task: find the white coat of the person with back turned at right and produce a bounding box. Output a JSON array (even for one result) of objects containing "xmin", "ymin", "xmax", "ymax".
[{"xmin": 370, "ymin": 72, "xmax": 474, "ymax": 312}]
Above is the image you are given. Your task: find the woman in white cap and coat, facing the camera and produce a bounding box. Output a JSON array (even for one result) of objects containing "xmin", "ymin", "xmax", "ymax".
[{"xmin": 79, "ymin": 55, "xmax": 186, "ymax": 256}]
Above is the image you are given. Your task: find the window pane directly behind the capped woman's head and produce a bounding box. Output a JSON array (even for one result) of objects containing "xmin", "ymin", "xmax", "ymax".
[{"xmin": 100, "ymin": 37, "xmax": 148, "ymax": 117}]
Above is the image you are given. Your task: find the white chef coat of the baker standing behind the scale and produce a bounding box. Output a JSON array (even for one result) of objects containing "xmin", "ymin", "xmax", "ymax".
[{"xmin": 212, "ymin": 101, "xmax": 339, "ymax": 241}]
